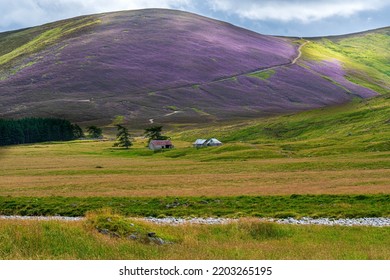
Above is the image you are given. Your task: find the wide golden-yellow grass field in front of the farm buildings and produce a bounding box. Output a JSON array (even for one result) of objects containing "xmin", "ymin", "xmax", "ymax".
[{"xmin": 0, "ymin": 142, "xmax": 390, "ymax": 197}]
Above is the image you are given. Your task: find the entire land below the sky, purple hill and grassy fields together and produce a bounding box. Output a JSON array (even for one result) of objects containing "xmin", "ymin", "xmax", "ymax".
[{"xmin": 0, "ymin": 10, "xmax": 390, "ymax": 259}]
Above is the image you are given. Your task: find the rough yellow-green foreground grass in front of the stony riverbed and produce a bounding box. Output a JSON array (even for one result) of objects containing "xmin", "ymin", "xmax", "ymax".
[{"xmin": 0, "ymin": 215, "xmax": 390, "ymax": 260}]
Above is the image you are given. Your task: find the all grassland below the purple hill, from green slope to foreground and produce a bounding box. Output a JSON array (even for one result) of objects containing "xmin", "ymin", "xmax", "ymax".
[{"xmin": 0, "ymin": 95, "xmax": 390, "ymax": 259}]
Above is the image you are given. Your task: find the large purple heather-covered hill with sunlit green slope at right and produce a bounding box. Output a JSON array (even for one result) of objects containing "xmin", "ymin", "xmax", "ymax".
[{"xmin": 0, "ymin": 9, "xmax": 390, "ymax": 126}]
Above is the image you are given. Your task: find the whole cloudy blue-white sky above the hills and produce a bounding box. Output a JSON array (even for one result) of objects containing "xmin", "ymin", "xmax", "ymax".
[{"xmin": 0, "ymin": 0, "xmax": 390, "ymax": 37}]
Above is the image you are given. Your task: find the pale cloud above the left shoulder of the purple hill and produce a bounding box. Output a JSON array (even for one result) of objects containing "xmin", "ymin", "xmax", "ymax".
[{"xmin": 0, "ymin": 0, "xmax": 192, "ymax": 31}]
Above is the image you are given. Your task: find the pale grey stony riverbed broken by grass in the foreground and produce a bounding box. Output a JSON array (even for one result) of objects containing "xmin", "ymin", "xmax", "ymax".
[{"xmin": 0, "ymin": 216, "xmax": 390, "ymax": 227}]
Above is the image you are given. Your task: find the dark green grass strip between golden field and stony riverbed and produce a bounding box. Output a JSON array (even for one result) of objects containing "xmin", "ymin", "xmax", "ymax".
[{"xmin": 0, "ymin": 194, "xmax": 390, "ymax": 218}]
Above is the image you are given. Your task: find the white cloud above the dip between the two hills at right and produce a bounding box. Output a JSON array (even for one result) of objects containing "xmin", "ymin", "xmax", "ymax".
[{"xmin": 209, "ymin": 0, "xmax": 390, "ymax": 23}]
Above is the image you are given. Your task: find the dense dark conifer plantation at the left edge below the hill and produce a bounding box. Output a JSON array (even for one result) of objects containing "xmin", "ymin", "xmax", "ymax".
[{"xmin": 0, "ymin": 118, "xmax": 84, "ymax": 146}]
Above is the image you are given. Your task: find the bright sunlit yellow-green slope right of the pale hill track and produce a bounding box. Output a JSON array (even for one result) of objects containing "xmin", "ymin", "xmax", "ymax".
[{"xmin": 303, "ymin": 28, "xmax": 390, "ymax": 93}]
